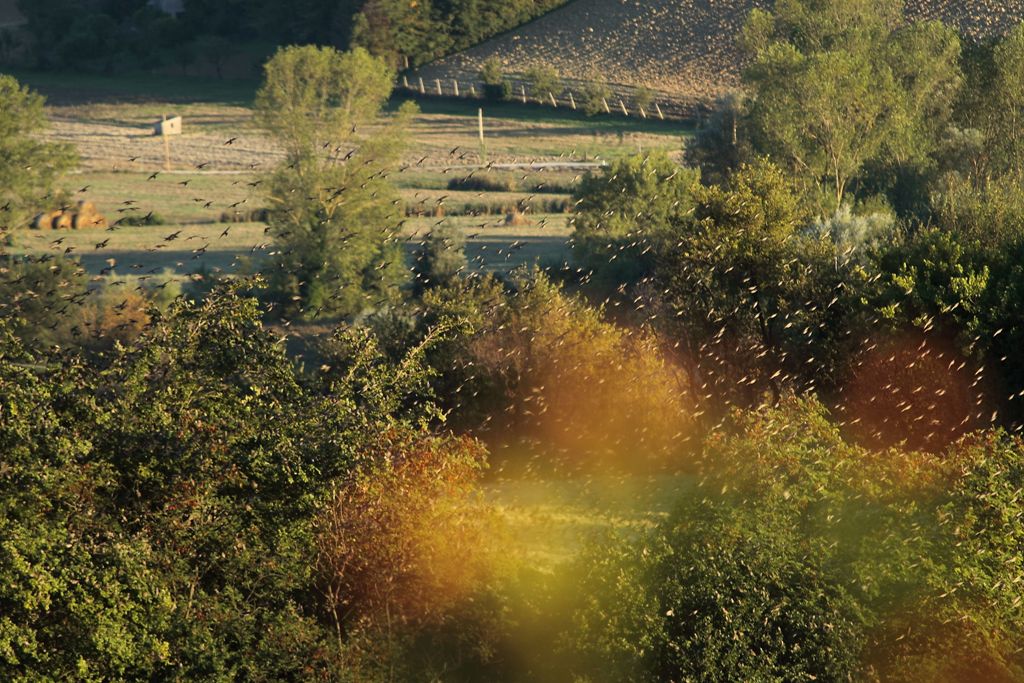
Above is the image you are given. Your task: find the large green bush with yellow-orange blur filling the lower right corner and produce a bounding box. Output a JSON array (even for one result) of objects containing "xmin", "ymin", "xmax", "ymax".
[{"xmin": 562, "ymin": 398, "xmax": 1024, "ymax": 683}]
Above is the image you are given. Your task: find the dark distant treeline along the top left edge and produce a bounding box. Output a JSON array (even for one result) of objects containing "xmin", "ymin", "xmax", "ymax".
[{"xmin": 8, "ymin": 0, "xmax": 565, "ymax": 76}]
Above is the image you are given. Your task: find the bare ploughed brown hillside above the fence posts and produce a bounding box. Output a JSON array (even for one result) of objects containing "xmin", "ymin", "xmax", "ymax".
[{"xmin": 411, "ymin": 0, "xmax": 1024, "ymax": 108}]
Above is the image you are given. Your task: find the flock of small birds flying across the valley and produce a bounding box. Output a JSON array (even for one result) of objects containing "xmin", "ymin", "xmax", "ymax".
[{"xmin": 0, "ymin": 120, "xmax": 1024, "ymax": 454}]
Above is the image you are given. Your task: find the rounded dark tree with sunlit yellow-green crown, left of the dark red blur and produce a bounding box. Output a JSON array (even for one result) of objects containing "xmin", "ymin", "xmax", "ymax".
[{"xmin": 654, "ymin": 162, "xmax": 862, "ymax": 403}]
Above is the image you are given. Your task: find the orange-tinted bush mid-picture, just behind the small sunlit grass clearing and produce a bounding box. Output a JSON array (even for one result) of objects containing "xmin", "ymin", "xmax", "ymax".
[{"xmin": 413, "ymin": 272, "xmax": 693, "ymax": 471}]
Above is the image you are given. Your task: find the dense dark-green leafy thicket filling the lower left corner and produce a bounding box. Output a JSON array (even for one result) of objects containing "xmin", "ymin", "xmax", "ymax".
[{"xmin": 0, "ymin": 282, "xmax": 507, "ymax": 680}]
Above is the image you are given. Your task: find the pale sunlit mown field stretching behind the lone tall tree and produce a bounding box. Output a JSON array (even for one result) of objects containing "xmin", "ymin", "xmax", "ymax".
[{"xmin": 11, "ymin": 68, "xmax": 692, "ymax": 276}]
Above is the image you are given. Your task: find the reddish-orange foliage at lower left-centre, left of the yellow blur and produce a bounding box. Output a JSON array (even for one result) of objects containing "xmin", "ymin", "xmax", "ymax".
[{"xmin": 316, "ymin": 433, "xmax": 496, "ymax": 636}]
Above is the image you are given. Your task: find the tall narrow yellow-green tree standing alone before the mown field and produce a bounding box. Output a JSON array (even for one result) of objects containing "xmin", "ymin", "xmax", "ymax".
[{"xmin": 256, "ymin": 46, "xmax": 415, "ymax": 317}]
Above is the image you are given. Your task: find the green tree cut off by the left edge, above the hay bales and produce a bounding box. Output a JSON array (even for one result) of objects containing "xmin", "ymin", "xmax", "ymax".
[{"xmin": 0, "ymin": 74, "xmax": 77, "ymax": 231}]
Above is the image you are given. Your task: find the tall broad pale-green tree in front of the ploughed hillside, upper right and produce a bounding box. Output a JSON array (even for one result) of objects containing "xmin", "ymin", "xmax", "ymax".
[{"xmin": 743, "ymin": 0, "xmax": 959, "ymax": 212}]
